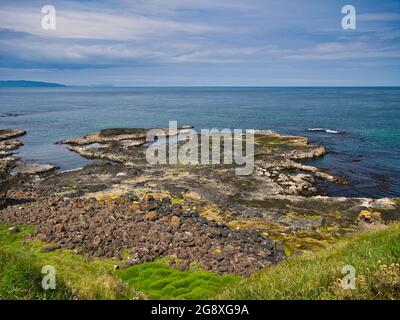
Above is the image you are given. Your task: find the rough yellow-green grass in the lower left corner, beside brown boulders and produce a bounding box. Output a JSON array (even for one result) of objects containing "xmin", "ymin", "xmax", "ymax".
[{"xmin": 0, "ymin": 225, "xmax": 132, "ymax": 299}]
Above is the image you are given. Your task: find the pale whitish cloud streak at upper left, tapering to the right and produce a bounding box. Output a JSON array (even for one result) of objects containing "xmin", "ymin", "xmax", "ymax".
[{"xmin": 0, "ymin": 7, "xmax": 226, "ymax": 40}]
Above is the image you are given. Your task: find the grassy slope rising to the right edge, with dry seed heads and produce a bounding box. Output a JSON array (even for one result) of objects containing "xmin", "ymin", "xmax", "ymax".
[{"xmin": 218, "ymin": 224, "xmax": 400, "ymax": 300}]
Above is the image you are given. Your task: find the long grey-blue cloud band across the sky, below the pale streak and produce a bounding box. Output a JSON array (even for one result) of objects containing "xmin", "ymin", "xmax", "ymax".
[{"xmin": 0, "ymin": 30, "xmax": 400, "ymax": 68}]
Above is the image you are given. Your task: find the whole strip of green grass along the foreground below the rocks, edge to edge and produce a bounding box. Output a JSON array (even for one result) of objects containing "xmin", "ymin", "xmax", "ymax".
[{"xmin": 0, "ymin": 223, "xmax": 400, "ymax": 299}]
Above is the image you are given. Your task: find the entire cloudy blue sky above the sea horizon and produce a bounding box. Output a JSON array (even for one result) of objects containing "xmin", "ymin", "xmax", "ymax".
[{"xmin": 0, "ymin": 0, "xmax": 400, "ymax": 86}]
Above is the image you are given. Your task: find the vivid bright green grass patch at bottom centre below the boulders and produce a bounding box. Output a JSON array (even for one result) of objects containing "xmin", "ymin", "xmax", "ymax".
[{"xmin": 118, "ymin": 262, "xmax": 240, "ymax": 299}]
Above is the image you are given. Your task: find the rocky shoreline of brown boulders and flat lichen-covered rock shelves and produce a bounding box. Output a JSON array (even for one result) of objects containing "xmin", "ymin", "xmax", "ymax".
[{"xmin": 0, "ymin": 126, "xmax": 400, "ymax": 275}]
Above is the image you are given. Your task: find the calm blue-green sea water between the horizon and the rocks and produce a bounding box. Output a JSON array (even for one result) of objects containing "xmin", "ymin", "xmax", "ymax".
[{"xmin": 0, "ymin": 88, "xmax": 400, "ymax": 197}]
